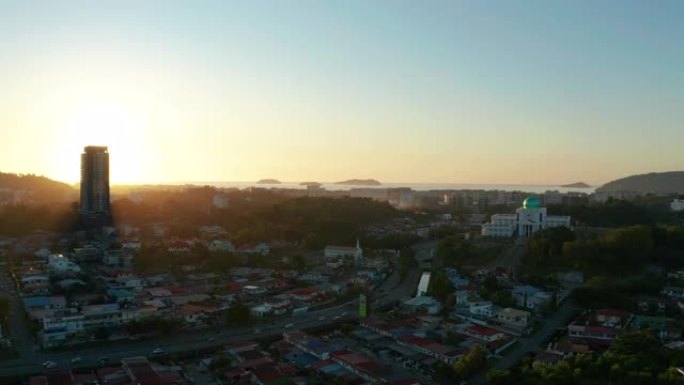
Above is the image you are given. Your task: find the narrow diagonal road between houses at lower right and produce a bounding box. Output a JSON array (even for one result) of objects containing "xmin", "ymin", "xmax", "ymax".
[{"xmin": 471, "ymin": 299, "xmax": 579, "ymax": 385}]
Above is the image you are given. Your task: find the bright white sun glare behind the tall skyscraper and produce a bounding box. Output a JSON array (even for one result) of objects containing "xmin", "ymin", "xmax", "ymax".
[{"xmin": 59, "ymin": 103, "xmax": 148, "ymax": 184}]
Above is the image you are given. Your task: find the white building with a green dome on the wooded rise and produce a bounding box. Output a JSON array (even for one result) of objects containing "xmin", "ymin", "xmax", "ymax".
[{"xmin": 482, "ymin": 197, "xmax": 570, "ymax": 238}]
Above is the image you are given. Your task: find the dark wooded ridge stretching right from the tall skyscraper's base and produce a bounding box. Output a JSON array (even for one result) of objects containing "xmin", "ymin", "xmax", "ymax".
[{"xmin": 113, "ymin": 187, "xmax": 403, "ymax": 249}]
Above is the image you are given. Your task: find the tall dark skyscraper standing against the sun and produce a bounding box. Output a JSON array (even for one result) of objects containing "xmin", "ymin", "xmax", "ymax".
[{"xmin": 81, "ymin": 146, "xmax": 111, "ymax": 219}]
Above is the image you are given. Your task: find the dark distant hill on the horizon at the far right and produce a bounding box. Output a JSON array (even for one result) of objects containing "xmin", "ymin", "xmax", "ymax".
[{"xmin": 596, "ymin": 171, "xmax": 684, "ymax": 194}]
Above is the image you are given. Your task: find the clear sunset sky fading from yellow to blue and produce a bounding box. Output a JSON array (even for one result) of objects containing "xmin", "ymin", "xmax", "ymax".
[{"xmin": 0, "ymin": 0, "xmax": 684, "ymax": 184}]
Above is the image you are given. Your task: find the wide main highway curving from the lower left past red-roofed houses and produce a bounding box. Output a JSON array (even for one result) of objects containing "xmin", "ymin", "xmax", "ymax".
[{"xmin": 0, "ymin": 244, "xmax": 430, "ymax": 382}]
